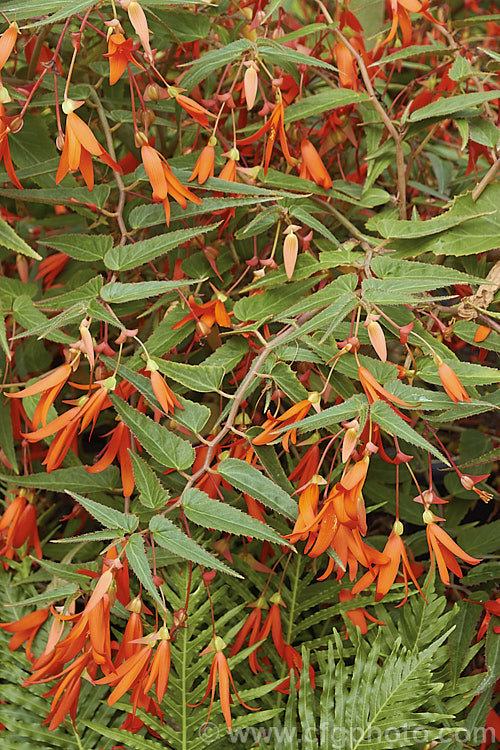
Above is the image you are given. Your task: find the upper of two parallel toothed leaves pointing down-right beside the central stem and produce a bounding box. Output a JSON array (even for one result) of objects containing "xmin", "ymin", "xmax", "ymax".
[{"xmin": 217, "ymin": 458, "xmax": 297, "ymax": 519}]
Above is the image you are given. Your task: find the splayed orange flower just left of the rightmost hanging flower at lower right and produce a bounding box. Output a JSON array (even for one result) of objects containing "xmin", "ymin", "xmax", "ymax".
[{"xmin": 352, "ymin": 521, "xmax": 425, "ymax": 607}]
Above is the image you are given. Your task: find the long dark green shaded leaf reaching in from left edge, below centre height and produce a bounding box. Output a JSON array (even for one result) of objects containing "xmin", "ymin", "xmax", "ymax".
[{"xmin": 0, "ymin": 466, "xmax": 121, "ymax": 492}]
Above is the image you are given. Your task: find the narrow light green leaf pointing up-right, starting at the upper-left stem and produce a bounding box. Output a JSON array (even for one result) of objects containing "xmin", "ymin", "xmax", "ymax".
[{"xmin": 104, "ymin": 229, "xmax": 219, "ymax": 271}]
